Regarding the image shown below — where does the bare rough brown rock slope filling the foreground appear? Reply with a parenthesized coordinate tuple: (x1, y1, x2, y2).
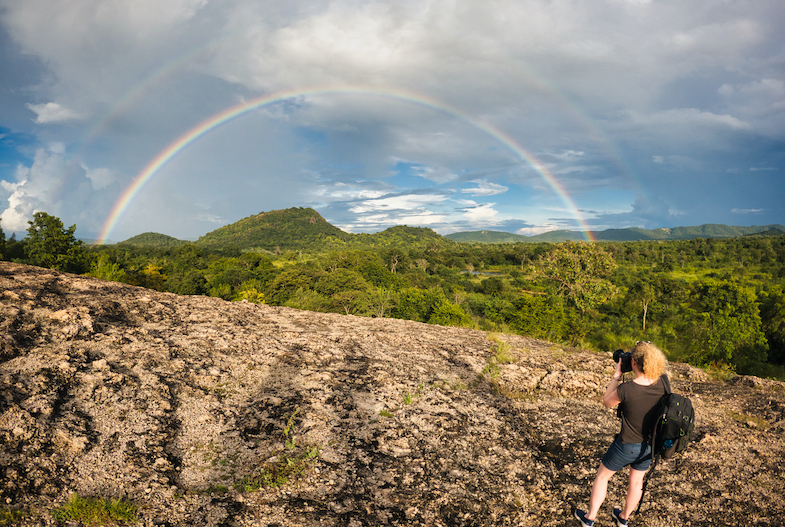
(0, 262, 785, 527)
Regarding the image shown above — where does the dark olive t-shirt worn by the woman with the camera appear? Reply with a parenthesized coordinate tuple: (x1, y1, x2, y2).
(616, 377, 666, 443)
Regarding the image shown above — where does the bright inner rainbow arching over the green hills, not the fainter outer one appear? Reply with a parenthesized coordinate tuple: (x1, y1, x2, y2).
(98, 86, 595, 244)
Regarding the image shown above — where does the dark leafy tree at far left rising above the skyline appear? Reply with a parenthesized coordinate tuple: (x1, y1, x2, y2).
(26, 212, 85, 272)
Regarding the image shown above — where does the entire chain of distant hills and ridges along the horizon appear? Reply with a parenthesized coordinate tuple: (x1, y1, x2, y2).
(116, 207, 785, 252)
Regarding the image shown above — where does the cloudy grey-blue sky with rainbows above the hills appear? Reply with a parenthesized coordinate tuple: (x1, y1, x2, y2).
(0, 0, 785, 243)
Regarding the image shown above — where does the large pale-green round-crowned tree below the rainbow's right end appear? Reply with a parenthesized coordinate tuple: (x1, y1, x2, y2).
(541, 242, 616, 314)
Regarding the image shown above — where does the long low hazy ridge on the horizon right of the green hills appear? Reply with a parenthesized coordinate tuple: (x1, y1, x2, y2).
(445, 223, 785, 243)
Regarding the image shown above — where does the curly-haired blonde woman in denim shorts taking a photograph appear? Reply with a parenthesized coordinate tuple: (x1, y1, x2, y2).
(575, 341, 668, 527)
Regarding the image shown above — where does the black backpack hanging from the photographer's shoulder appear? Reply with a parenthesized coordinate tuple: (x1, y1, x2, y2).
(636, 375, 695, 514)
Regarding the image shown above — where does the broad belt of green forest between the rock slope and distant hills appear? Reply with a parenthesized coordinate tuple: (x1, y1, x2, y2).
(0, 213, 785, 378)
